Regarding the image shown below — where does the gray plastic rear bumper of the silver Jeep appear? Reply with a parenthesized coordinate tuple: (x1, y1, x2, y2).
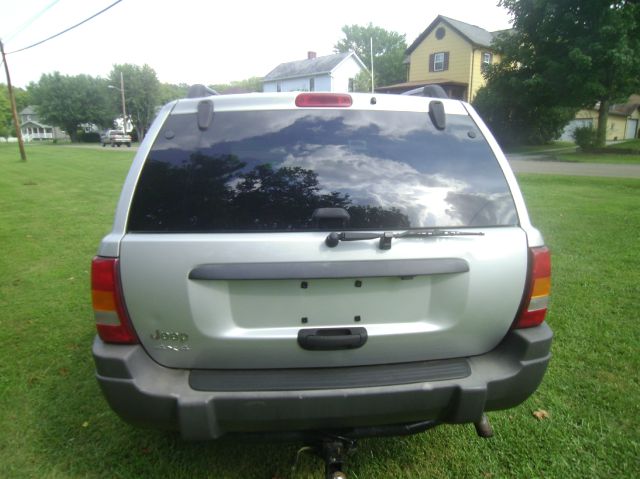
(93, 323, 553, 439)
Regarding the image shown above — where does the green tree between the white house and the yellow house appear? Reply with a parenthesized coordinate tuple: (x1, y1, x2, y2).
(333, 23, 407, 85)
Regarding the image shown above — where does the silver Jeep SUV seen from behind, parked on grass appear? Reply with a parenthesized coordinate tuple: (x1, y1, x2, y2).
(92, 93, 552, 456)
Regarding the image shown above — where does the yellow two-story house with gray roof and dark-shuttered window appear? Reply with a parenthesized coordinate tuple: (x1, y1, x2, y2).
(376, 15, 504, 101)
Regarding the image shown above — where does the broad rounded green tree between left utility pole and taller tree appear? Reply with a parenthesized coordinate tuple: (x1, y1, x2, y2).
(28, 72, 113, 141)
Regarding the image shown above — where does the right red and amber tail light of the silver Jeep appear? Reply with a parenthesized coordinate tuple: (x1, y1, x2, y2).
(514, 246, 551, 328)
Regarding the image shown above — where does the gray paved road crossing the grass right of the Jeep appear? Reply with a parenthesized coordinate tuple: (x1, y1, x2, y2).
(507, 154, 640, 178)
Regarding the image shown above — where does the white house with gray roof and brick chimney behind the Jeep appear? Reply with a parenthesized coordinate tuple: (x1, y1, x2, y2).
(262, 52, 367, 92)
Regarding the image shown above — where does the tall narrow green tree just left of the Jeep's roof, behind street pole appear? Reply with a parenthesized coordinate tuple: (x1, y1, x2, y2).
(109, 63, 160, 141)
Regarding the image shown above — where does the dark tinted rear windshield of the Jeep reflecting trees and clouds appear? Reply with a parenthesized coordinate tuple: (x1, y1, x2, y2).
(128, 109, 517, 232)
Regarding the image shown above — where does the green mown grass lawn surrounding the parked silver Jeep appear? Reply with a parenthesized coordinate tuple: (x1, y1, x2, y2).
(0, 145, 640, 479)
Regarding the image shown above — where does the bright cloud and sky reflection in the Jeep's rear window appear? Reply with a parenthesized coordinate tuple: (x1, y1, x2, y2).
(144, 110, 517, 227)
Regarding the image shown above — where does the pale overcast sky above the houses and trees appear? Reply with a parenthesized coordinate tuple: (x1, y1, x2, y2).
(0, 0, 510, 87)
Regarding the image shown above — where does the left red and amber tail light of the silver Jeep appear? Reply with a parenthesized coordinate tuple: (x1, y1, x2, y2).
(91, 256, 138, 344)
